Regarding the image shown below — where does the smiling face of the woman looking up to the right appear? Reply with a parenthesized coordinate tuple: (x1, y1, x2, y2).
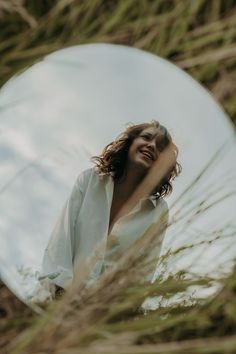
(128, 126, 168, 170)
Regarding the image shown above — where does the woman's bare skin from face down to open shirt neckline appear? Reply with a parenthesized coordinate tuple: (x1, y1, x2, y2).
(108, 127, 176, 234)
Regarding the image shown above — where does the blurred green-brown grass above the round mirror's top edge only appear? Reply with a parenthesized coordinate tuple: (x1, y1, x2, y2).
(0, 0, 236, 122)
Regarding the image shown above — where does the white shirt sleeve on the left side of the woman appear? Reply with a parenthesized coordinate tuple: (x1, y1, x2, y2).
(40, 174, 84, 288)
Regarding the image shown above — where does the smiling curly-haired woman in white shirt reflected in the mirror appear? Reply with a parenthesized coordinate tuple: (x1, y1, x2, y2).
(43, 121, 181, 296)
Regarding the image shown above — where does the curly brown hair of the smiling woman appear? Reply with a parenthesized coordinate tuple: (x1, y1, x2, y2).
(92, 120, 182, 199)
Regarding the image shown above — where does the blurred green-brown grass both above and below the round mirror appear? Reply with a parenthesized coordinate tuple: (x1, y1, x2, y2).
(0, 0, 236, 354)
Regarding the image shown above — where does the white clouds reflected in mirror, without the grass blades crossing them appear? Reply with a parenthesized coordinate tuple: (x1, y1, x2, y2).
(0, 44, 236, 300)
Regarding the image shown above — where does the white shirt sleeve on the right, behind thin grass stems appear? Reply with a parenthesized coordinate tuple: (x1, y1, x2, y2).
(146, 201, 169, 283)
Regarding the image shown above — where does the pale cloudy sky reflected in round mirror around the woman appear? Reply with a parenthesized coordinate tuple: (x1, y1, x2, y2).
(0, 44, 236, 308)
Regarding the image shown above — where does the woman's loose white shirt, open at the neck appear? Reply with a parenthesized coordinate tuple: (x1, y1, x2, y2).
(42, 168, 168, 288)
